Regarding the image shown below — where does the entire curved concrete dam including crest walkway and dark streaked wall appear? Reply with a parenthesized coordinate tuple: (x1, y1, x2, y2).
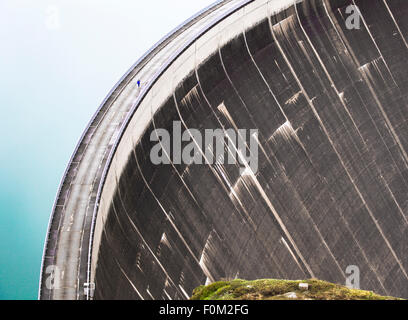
(39, 0, 408, 300)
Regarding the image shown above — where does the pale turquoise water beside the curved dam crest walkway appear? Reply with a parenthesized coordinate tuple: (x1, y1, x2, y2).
(0, 0, 213, 299)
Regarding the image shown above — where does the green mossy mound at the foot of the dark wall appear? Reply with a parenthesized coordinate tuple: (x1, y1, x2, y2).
(191, 279, 404, 300)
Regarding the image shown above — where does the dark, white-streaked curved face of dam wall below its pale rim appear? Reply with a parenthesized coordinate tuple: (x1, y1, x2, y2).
(40, 0, 408, 299)
